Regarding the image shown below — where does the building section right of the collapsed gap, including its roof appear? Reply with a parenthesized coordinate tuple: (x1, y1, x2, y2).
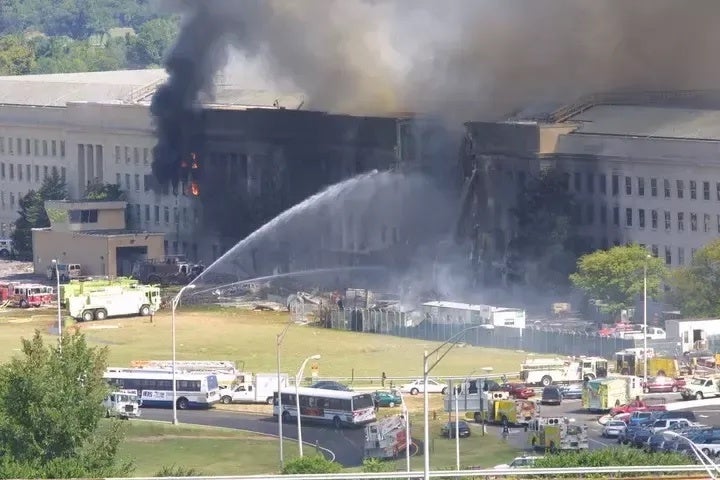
(459, 91, 720, 280)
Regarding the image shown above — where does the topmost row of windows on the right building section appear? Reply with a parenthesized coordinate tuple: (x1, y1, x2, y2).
(568, 172, 720, 201)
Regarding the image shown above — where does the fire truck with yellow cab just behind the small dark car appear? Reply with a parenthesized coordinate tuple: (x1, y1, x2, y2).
(444, 386, 538, 425)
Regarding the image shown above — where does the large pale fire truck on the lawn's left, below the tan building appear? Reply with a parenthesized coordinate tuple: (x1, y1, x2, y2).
(67, 286, 160, 322)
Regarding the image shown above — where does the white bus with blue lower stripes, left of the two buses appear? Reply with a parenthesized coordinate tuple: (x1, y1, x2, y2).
(103, 368, 220, 410)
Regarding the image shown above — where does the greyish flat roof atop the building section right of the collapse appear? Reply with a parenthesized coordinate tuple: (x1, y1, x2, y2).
(568, 105, 720, 140)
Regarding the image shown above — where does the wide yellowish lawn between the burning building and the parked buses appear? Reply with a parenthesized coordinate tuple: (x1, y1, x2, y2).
(0, 308, 525, 377)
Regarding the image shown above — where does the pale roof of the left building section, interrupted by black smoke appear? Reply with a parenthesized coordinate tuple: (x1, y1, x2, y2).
(0, 69, 305, 110)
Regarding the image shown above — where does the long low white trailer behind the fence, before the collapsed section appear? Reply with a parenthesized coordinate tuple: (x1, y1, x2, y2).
(422, 301, 525, 328)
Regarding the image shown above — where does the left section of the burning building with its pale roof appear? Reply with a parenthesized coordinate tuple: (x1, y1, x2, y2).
(0, 70, 416, 264)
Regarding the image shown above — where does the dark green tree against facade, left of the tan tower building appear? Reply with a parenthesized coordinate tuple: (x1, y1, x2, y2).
(12, 170, 67, 255)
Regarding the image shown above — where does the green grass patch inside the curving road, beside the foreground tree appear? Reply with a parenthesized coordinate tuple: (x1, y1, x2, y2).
(119, 420, 297, 477)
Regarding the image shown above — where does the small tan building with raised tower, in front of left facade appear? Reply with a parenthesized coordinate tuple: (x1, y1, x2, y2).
(32, 200, 165, 277)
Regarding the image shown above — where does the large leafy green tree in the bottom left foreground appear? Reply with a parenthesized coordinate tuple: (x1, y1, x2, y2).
(0, 331, 131, 478)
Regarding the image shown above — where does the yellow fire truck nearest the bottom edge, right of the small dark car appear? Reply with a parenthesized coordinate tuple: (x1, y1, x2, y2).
(528, 417, 590, 453)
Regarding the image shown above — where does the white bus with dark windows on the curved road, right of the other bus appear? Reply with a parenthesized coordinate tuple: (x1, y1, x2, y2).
(273, 387, 376, 428)
